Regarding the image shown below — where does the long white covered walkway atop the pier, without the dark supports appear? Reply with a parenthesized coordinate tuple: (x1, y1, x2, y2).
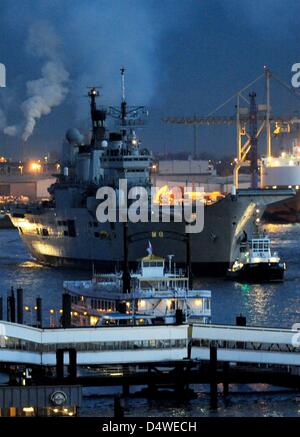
(0, 322, 300, 366)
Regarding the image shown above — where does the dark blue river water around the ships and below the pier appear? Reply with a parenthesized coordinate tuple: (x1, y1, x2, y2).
(0, 224, 300, 416)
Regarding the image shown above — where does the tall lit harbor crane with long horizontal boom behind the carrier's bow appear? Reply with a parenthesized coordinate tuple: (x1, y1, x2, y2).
(162, 66, 300, 188)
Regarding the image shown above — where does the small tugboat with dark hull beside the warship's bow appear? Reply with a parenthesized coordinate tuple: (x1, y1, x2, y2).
(227, 234, 286, 283)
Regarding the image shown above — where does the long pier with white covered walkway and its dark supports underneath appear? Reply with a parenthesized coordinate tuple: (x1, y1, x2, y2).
(0, 316, 300, 408)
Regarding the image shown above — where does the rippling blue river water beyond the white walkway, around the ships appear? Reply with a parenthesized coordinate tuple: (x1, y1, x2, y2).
(0, 224, 300, 328)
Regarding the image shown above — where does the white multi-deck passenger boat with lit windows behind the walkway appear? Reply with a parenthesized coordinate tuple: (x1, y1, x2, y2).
(63, 244, 211, 326)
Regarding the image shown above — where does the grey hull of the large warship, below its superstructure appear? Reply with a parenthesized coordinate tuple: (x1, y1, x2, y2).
(9, 190, 293, 276)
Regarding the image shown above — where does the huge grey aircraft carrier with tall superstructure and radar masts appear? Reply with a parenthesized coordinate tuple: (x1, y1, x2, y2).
(8, 70, 293, 275)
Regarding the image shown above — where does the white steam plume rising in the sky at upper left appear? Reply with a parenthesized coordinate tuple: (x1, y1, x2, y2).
(21, 22, 69, 141)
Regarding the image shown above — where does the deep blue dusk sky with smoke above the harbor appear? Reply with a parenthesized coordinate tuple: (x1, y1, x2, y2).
(0, 0, 300, 156)
